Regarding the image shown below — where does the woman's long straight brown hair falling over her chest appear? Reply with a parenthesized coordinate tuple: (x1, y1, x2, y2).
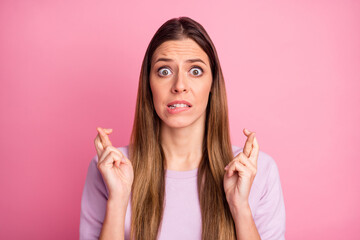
(129, 17, 236, 240)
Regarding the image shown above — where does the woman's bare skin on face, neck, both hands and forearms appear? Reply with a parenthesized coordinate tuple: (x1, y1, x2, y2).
(94, 39, 260, 239)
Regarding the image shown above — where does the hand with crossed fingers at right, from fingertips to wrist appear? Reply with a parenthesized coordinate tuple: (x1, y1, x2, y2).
(224, 129, 259, 209)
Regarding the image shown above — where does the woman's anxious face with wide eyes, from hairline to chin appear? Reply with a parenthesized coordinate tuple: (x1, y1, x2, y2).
(150, 38, 212, 128)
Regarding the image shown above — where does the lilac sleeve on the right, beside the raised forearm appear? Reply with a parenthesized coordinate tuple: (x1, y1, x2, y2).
(254, 157, 285, 240)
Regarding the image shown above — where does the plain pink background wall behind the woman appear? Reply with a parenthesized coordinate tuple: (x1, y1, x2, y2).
(0, 0, 360, 240)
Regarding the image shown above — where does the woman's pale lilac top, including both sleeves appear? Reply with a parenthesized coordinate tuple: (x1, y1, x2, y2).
(79, 146, 285, 240)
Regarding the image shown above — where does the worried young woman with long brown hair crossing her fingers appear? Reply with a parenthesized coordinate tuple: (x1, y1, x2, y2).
(80, 17, 285, 240)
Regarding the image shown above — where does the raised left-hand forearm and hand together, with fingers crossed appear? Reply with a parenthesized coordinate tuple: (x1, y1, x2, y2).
(94, 127, 134, 240)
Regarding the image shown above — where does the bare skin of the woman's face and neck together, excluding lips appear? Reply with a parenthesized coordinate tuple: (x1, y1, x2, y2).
(150, 39, 212, 171)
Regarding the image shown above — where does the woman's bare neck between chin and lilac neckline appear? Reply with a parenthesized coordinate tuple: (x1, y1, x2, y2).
(160, 116, 205, 171)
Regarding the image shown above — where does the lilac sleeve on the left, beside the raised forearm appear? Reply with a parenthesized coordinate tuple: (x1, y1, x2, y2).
(79, 155, 108, 240)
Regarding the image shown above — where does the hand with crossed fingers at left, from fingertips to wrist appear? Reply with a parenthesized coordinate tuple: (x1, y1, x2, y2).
(94, 127, 134, 199)
